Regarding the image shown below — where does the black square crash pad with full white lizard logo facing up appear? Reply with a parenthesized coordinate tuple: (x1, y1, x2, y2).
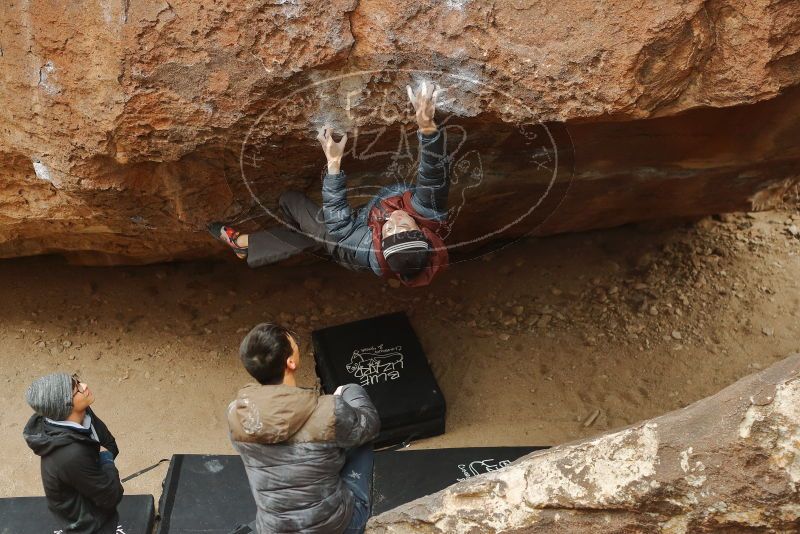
(311, 312, 445, 447)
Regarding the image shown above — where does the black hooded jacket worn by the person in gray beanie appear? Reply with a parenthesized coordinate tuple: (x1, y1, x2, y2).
(22, 409, 123, 534)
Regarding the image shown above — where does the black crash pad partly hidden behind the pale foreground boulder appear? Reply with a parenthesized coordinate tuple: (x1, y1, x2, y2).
(372, 447, 546, 515)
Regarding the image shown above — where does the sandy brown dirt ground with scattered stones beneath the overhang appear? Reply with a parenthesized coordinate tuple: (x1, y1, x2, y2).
(0, 200, 800, 497)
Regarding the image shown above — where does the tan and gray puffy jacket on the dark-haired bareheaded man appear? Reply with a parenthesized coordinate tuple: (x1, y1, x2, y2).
(228, 384, 380, 534)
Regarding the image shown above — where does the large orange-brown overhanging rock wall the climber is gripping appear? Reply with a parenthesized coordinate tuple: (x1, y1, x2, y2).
(0, 0, 800, 263)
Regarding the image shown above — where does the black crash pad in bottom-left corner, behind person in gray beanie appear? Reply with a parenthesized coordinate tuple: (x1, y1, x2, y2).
(0, 495, 155, 534)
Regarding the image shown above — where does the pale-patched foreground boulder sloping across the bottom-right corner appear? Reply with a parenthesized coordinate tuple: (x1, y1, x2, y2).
(367, 354, 800, 534)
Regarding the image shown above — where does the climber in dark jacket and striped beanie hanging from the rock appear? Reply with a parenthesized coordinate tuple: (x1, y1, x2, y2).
(209, 82, 450, 287)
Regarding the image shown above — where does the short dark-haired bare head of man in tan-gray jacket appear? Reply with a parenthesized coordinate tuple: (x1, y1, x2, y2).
(239, 323, 292, 385)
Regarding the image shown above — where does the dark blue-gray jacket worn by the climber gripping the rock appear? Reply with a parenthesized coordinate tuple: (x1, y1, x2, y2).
(322, 129, 450, 276)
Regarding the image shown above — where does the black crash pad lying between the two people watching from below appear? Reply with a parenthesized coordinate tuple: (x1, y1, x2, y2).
(157, 454, 256, 534)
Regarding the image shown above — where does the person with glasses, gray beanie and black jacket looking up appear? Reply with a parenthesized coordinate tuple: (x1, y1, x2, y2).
(22, 373, 123, 534)
